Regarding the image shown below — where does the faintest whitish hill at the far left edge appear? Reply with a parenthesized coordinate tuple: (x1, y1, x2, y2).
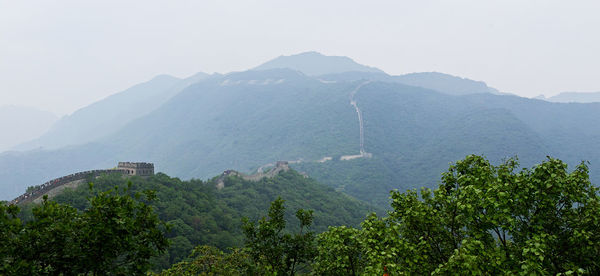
(0, 105, 58, 152)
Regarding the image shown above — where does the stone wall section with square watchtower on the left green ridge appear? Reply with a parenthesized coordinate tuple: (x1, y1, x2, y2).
(10, 162, 154, 204)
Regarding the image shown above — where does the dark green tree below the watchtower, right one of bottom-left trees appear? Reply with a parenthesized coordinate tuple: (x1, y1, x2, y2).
(81, 185, 169, 274)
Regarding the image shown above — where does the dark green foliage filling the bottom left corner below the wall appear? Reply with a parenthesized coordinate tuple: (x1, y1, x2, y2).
(0, 184, 168, 275)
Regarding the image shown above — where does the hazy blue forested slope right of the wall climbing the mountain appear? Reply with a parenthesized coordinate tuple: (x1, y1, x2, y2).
(296, 83, 600, 206)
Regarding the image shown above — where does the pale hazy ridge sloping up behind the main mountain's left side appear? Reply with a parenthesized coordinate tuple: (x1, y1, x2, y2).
(17, 73, 208, 150)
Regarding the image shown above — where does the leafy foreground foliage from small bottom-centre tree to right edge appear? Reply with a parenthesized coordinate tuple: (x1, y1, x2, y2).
(156, 155, 600, 275)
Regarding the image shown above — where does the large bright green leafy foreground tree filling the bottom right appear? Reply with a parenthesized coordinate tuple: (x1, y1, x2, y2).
(362, 155, 600, 275)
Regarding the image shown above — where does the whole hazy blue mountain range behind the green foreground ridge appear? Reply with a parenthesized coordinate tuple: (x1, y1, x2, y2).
(0, 52, 600, 206)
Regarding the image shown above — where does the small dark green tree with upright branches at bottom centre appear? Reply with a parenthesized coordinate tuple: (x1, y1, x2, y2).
(242, 198, 316, 275)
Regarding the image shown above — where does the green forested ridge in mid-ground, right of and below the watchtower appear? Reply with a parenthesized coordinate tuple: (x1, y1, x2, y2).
(34, 170, 379, 268)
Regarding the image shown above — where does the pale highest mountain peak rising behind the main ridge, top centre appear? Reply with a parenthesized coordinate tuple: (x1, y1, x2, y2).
(253, 51, 383, 76)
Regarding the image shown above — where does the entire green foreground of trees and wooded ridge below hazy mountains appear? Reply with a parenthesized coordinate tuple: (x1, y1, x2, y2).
(0, 155, 600, 275)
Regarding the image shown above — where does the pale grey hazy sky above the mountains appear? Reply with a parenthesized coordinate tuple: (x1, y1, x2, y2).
(0, 0, 600, 114)
